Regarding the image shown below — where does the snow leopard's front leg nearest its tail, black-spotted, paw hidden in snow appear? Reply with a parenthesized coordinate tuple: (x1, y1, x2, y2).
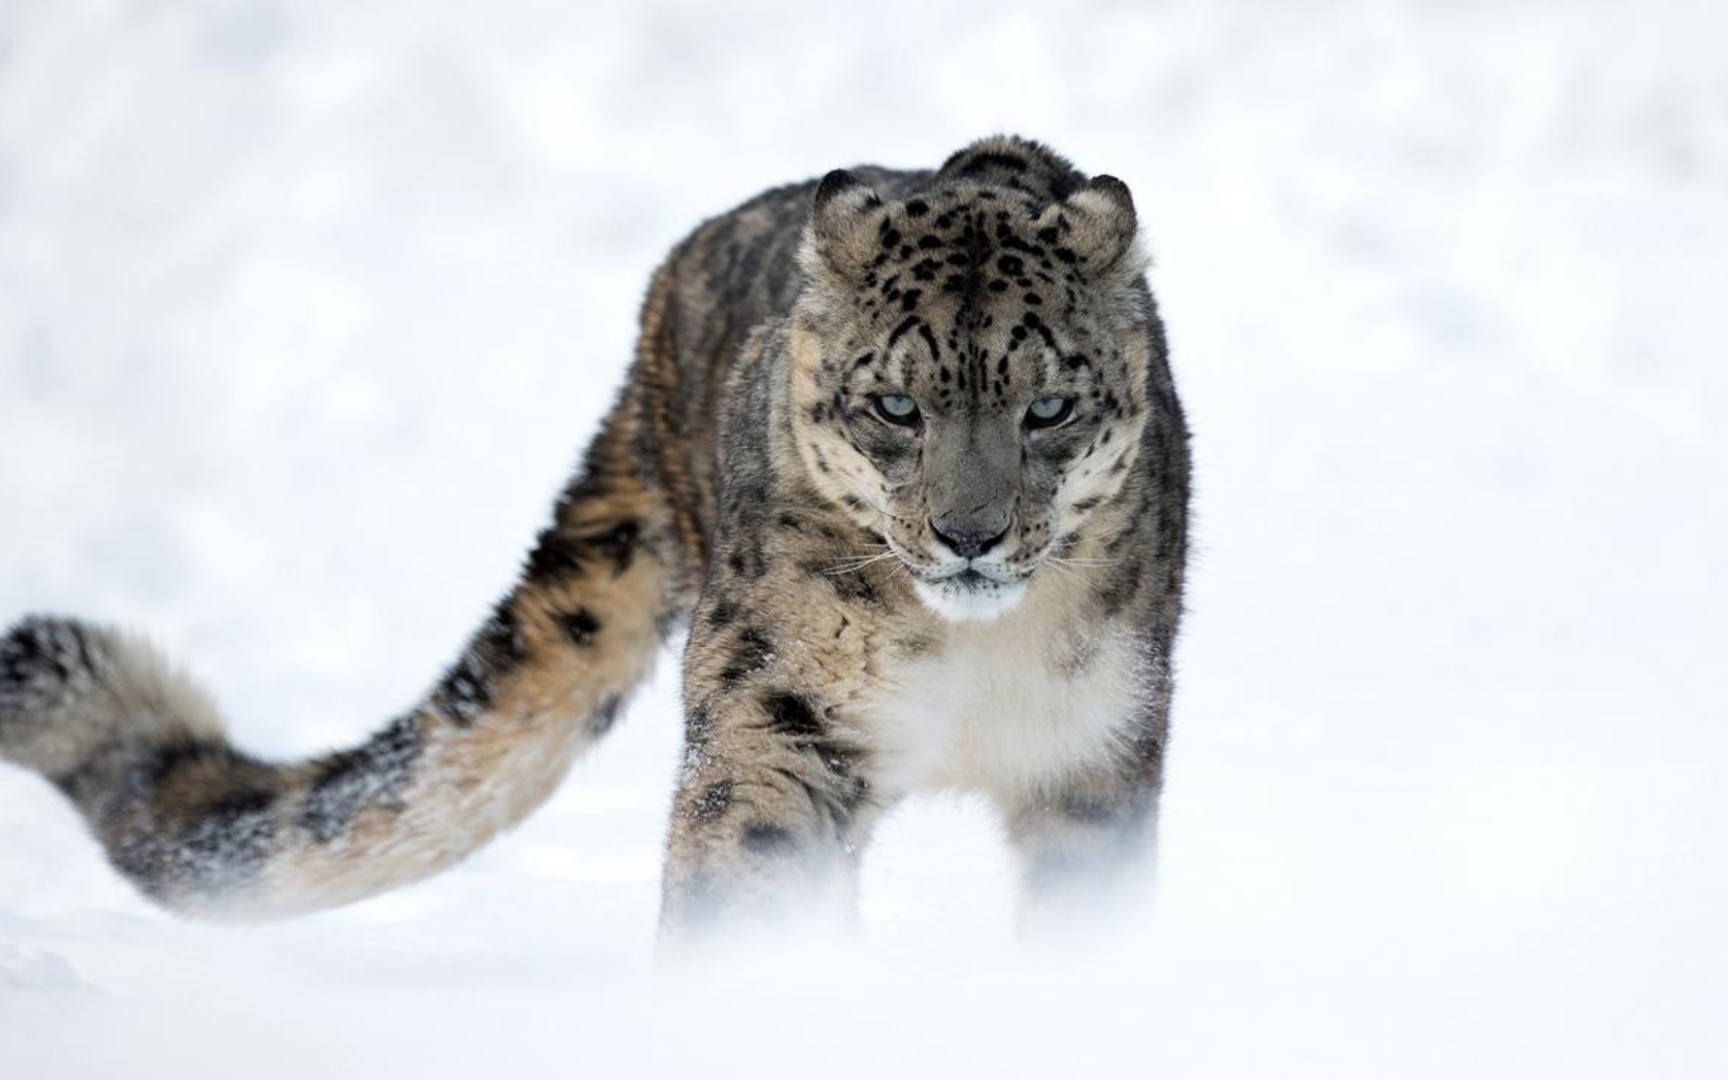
(660, 605, 874, 942)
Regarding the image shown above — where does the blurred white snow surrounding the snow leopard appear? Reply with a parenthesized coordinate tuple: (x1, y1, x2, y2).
(0, 0, 1728, 1080)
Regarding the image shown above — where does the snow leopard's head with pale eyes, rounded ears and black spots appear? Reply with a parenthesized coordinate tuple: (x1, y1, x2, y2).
(791, 173, 1149, 620)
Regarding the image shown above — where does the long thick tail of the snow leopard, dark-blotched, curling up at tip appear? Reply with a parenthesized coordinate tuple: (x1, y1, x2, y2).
(0, 403, 689, 919)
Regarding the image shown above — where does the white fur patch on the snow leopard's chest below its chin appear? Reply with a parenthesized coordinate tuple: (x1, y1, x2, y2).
(861, 605, 1147, 795)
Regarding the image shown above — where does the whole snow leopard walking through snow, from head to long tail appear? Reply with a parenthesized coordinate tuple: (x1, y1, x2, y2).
(0, 137, 1191, 940)
